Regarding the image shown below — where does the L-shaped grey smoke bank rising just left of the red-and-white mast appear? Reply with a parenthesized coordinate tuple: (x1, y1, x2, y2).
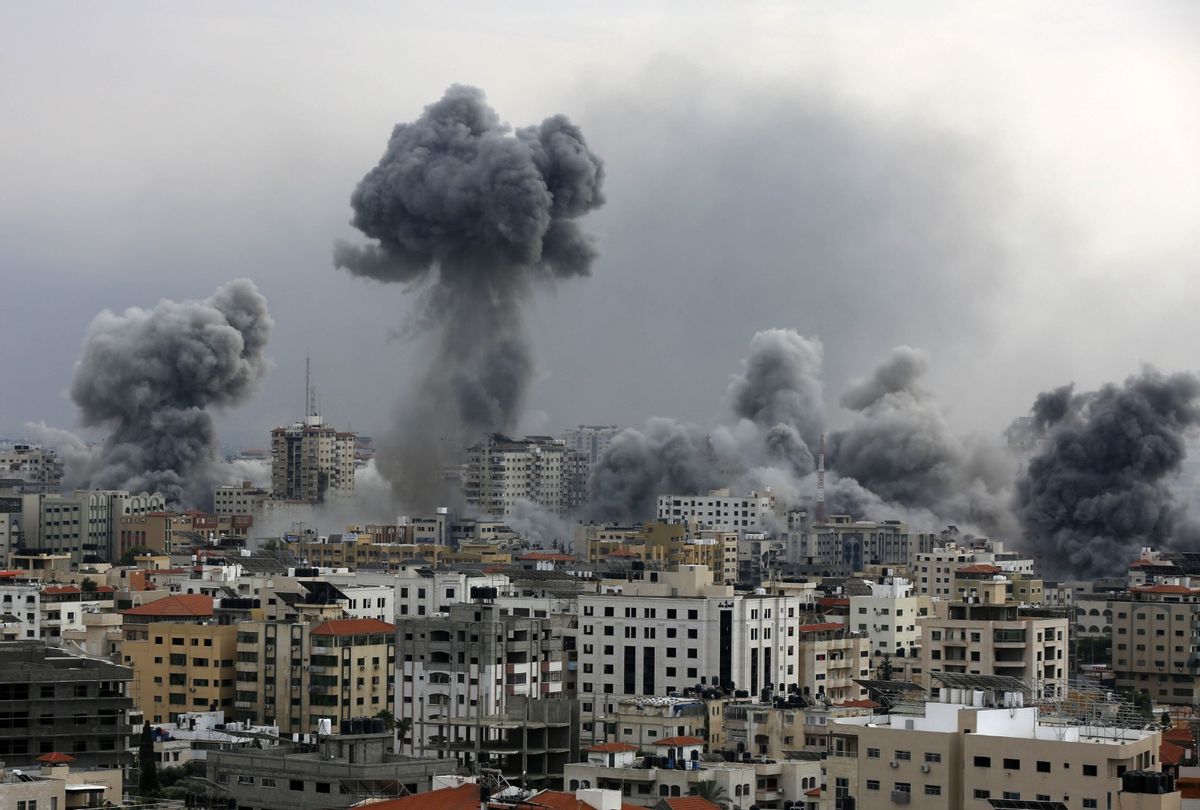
(589, 329, 824, 521)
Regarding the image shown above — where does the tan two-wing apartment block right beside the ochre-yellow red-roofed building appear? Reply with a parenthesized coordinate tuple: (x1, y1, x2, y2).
(234, 618, 396, 733)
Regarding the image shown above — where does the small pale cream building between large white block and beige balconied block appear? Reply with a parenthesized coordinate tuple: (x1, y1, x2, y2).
(848, 577, 932, 680)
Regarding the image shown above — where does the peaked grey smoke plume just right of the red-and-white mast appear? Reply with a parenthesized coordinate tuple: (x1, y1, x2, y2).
(828, 346, 1014, 536)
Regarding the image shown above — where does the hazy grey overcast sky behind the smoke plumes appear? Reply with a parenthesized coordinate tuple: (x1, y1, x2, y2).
(0, 0, 1200, 448)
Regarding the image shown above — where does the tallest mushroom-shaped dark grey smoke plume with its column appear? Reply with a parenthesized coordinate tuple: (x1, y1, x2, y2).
(334, 85, 604, 505)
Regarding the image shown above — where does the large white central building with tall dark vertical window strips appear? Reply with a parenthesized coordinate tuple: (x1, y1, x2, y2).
(578, 565, 815, 715)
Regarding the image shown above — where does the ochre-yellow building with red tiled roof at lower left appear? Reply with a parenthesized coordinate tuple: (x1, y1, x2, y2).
(120, 594, 236, 722)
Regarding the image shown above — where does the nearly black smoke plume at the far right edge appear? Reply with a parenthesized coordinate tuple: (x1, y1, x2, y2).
(1016, 370, 1200, 578)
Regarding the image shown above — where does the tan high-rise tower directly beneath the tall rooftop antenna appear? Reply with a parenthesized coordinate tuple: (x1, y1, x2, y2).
(271, 416, 355, 504)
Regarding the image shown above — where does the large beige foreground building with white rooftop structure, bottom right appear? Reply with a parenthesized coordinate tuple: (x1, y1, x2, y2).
(821, 676, 1180, 810)
